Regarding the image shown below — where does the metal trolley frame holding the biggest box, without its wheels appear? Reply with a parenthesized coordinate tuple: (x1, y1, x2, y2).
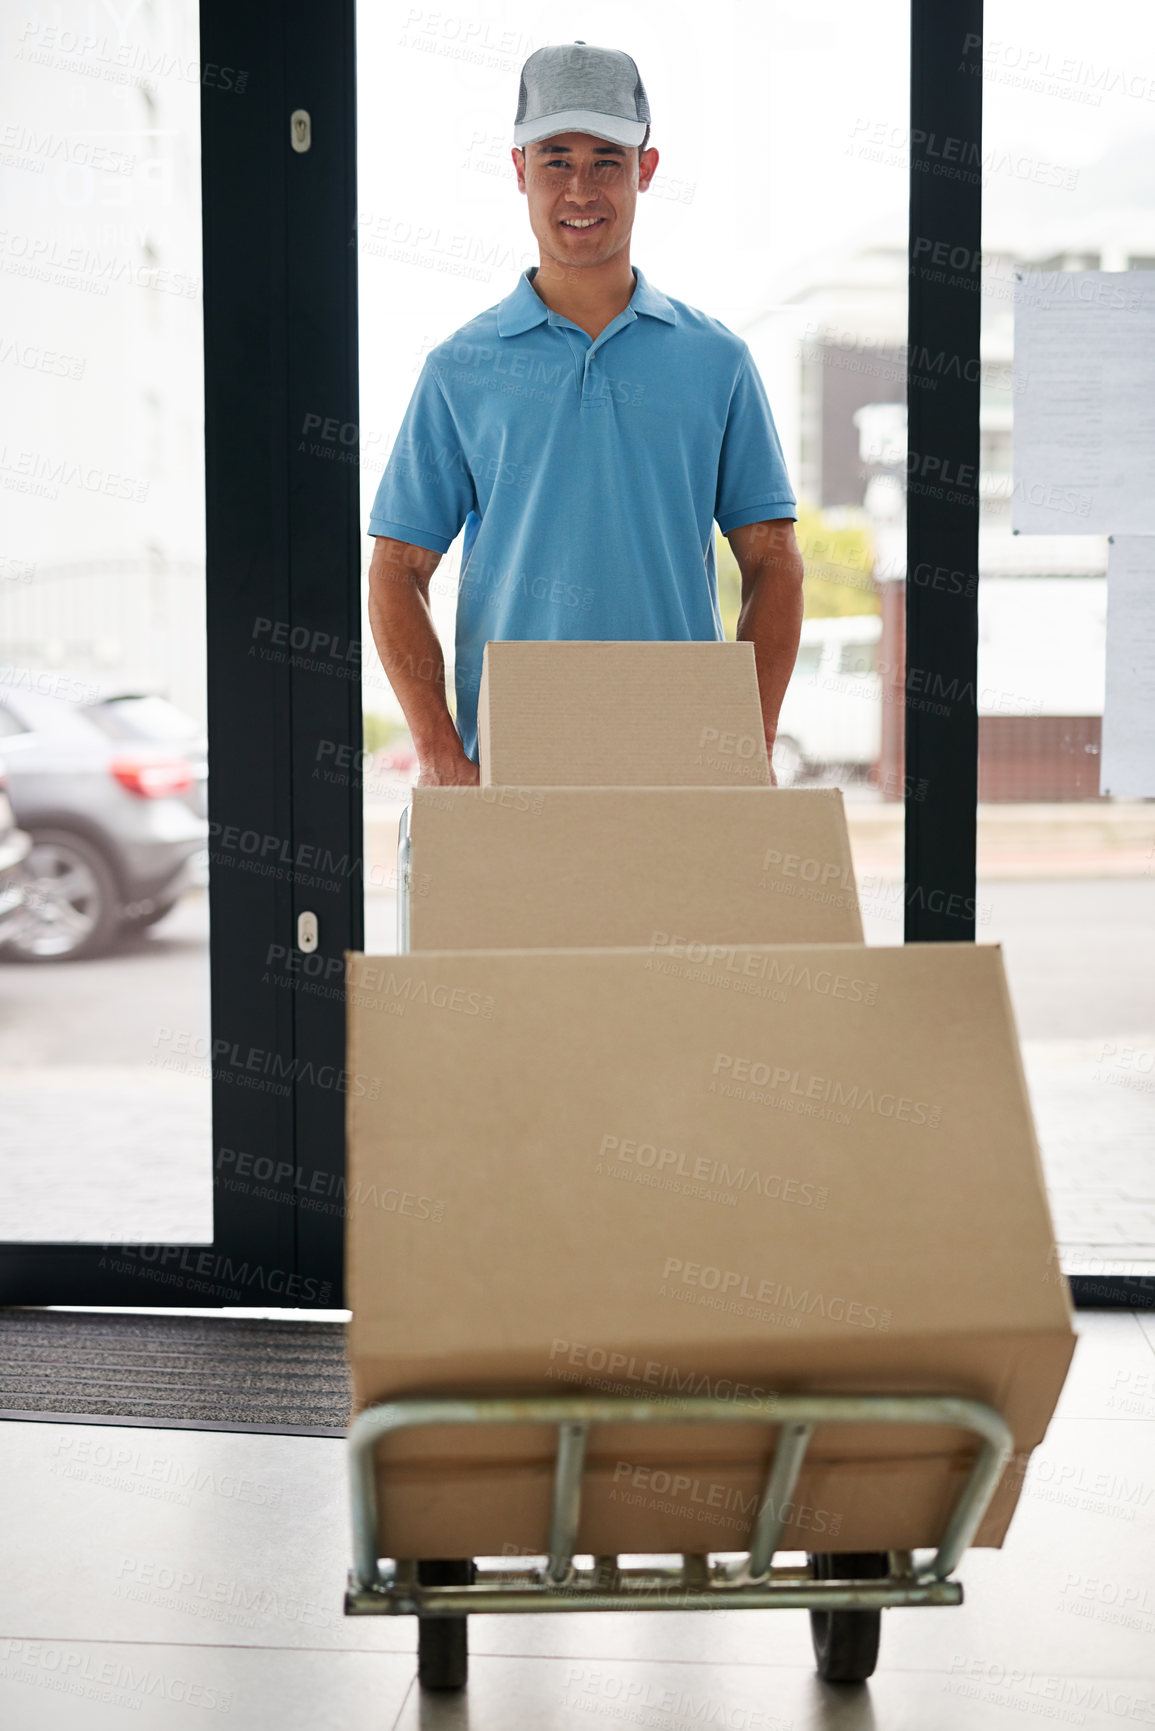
(345, 1393, 1011, 1617)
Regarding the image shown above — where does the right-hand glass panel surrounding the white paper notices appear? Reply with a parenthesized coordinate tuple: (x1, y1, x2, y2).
(971, 0, 1155, 1303)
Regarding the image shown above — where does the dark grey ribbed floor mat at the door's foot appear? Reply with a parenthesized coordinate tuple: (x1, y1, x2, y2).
(0, 1309, 350, 1437)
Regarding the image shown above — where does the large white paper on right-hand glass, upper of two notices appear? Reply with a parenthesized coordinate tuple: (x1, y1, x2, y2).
(1011, 270, 1155, 535)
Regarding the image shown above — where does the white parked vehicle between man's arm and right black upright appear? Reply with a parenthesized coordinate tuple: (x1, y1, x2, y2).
(774, 613, 881, 788)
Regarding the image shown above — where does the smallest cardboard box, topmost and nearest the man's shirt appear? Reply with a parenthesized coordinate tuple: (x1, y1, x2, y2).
(478, 642, 771, 788)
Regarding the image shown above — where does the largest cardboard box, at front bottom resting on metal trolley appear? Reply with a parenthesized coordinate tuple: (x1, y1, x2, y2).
(346, 943, 1074, 1556)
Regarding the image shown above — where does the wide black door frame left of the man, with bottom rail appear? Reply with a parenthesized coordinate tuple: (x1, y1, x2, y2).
(0, 0, 361, 1309)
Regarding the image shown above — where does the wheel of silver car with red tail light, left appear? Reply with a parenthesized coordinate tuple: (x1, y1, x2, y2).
(3, 829, 119, 962)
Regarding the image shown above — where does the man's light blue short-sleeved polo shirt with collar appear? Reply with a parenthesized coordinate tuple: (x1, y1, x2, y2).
(369, 265, 797, 760)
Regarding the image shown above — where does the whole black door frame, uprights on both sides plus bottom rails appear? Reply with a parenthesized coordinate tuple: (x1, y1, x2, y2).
(0, 0, 1135, 1309)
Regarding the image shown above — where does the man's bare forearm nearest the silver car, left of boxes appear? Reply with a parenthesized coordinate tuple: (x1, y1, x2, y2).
(369, 537, 464, 765)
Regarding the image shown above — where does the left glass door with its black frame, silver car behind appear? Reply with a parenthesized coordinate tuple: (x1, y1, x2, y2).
(0, 0, 362, 1309)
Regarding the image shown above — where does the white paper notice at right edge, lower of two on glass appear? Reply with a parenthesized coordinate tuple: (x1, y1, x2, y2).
(1100, 535, 1155, 800)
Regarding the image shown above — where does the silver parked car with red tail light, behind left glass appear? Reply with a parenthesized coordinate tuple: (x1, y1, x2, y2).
(0, 673, 208, 961)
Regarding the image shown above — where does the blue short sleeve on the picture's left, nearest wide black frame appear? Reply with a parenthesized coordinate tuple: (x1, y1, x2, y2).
(369, 357, 476, 552)
